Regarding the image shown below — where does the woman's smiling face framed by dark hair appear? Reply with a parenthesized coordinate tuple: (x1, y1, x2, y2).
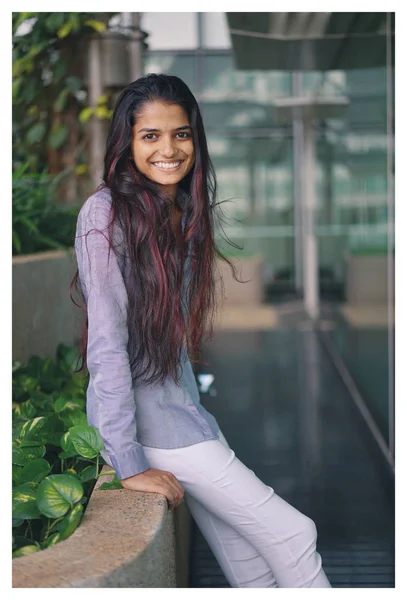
(131, 100, 195, 198)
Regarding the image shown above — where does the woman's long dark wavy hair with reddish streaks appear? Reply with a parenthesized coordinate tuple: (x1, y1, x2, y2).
(70, 74, 244, 383)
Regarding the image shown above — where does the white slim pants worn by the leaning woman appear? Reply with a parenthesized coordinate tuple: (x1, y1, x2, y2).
(144, 434, 331, 588)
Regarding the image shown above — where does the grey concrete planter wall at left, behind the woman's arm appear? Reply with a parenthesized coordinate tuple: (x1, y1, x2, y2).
(12, 248, 84, 361)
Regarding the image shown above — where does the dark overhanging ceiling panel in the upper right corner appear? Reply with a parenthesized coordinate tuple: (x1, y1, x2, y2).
(227, 12, 395, 71)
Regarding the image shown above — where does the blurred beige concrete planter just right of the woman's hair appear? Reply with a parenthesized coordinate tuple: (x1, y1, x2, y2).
(217, 255, 264, 309)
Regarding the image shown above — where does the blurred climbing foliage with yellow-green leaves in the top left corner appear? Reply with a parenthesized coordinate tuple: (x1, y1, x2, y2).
(12, 12, 117, 173)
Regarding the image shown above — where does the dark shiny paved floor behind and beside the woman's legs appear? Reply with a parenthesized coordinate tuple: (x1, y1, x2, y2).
(191, 323, 394, 588)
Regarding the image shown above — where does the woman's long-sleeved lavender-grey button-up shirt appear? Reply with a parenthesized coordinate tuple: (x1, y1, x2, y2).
(75, 188, 219, 479)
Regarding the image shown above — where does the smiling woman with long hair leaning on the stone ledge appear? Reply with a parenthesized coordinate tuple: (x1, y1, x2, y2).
(75, 74, 330, 587)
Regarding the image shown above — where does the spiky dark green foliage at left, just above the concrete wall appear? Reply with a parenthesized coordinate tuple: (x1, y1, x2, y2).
(12, 163, 80, 255)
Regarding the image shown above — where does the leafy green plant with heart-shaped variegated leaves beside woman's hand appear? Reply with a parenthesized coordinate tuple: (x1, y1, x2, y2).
(12, 345, 122, 557)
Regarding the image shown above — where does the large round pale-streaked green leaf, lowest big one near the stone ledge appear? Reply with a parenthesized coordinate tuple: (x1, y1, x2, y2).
(37, 475, 83, 518)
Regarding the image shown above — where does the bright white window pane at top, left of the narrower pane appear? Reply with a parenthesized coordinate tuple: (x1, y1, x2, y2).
(141, 12, 198, 50)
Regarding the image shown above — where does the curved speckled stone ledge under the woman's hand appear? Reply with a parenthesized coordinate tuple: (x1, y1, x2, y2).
(12, 465, 190, 588)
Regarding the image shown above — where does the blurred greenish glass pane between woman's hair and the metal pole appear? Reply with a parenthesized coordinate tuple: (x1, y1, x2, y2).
(208, 134, 294, 285)
